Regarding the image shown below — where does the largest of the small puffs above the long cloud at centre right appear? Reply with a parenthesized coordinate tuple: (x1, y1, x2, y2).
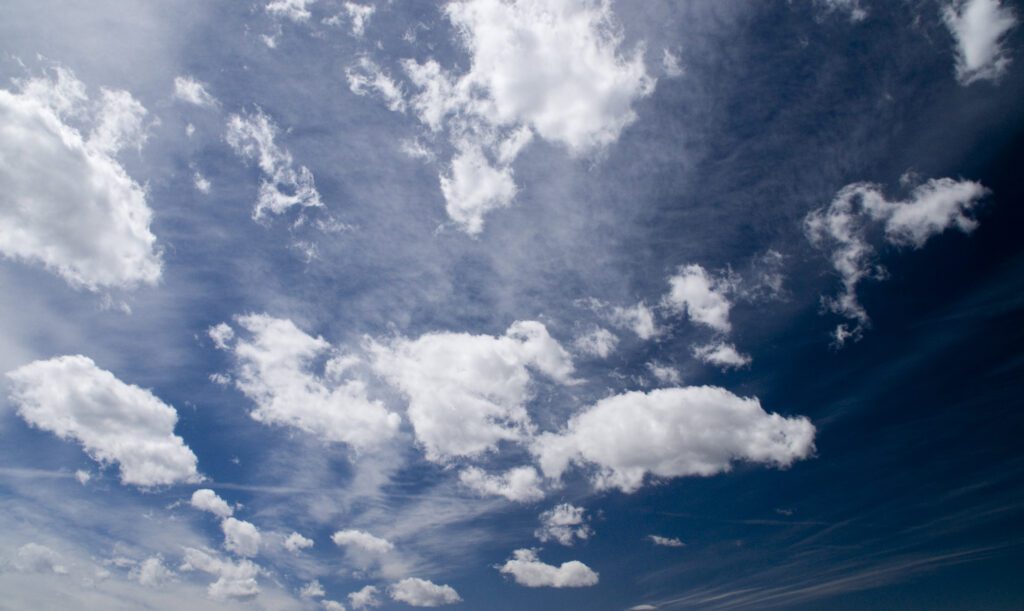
(663, 265, 732, 333)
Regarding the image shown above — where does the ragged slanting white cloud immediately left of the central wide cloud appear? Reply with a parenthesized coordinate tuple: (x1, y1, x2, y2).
(220, 314, 400, 449)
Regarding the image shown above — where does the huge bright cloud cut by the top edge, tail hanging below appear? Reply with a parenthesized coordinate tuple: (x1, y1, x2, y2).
(393, 0, 654, 234)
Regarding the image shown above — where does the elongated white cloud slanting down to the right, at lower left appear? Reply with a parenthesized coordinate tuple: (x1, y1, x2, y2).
(7, 355, 200, 487)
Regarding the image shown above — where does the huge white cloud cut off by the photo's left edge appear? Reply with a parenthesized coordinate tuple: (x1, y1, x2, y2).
(0, 68, 163, 291)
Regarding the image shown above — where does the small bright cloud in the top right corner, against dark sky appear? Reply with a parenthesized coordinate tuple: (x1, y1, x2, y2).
(942, 0, 1017, 86)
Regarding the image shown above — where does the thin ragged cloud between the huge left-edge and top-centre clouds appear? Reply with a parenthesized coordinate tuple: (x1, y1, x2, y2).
(225, 108, 324, 220)
